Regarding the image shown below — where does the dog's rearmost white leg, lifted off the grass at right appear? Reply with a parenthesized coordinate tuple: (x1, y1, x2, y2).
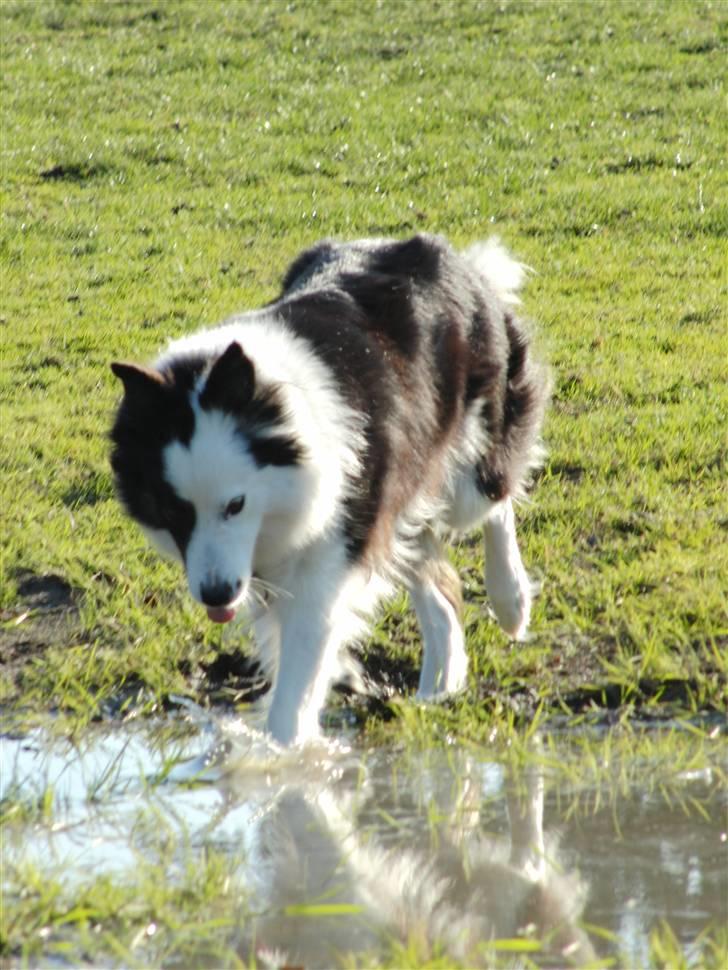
(483, 498, 532, 640)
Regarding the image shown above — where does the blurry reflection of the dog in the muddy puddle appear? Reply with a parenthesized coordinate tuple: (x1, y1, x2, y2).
(233, 765, 595, 968)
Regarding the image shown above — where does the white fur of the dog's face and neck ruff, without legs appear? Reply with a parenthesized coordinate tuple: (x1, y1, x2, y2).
(147, 315, 360, 605)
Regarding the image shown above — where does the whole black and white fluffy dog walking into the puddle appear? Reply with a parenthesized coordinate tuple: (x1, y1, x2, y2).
(111, 234, 548, 746)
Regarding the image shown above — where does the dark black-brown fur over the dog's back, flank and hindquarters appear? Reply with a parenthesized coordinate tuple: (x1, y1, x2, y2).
(270, 235, 546, 558)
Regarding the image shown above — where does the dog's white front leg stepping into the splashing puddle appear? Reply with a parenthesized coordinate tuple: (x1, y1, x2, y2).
(267, 548, 361, 745)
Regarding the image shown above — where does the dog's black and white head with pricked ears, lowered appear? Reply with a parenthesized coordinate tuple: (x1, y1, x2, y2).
(111, 343, 302, 622)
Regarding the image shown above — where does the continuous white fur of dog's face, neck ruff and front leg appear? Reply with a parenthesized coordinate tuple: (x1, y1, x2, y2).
(151, 317, 389, 744)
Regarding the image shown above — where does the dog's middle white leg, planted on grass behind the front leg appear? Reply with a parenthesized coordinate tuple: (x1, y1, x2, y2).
(408, 531, 468, 700)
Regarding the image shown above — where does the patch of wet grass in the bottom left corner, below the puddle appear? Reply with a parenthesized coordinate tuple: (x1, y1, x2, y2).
(3, 840, 248, 967)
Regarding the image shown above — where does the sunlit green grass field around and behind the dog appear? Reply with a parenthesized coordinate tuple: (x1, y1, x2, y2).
(0, 0, 728, 965)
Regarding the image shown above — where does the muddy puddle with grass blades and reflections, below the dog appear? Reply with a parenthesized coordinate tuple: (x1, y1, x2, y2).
(0, 708, 728, 967)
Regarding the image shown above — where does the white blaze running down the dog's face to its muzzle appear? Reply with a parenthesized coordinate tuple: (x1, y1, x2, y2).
(163, 408, 266, 605)
